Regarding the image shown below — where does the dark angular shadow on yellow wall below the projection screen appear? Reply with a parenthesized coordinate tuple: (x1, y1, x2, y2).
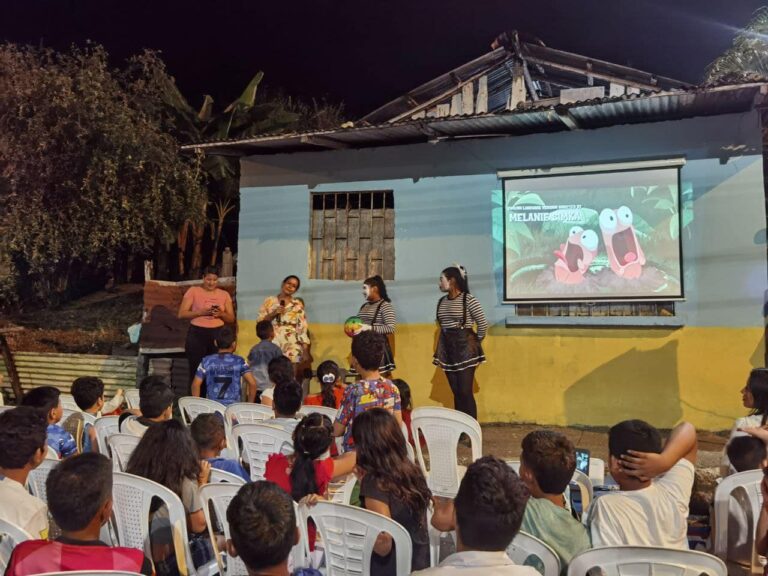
(565, 342, 682, 428)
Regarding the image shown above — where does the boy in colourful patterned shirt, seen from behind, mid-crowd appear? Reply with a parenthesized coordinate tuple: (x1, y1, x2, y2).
(333, 331, 403, 452)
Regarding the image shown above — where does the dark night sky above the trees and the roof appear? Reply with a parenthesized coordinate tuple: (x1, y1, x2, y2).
(0, 0, 768, 118)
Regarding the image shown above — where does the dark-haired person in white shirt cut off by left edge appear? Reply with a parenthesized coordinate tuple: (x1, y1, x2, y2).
(0, 406, 48, 540)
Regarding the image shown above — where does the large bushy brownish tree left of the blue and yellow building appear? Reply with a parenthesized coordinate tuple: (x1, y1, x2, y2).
(0, 44, 205, 304)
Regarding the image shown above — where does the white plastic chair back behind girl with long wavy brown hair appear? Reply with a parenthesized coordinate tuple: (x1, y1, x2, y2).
(299, 501, 413, 576)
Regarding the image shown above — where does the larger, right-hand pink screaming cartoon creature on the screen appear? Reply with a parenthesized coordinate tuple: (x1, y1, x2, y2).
(600, 206, 645, 280)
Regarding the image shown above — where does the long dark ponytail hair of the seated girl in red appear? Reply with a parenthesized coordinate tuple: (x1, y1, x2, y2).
(291, 412, 333, 502)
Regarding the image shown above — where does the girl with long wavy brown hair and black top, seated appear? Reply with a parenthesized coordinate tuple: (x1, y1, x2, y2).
(352, 408, 432, 576)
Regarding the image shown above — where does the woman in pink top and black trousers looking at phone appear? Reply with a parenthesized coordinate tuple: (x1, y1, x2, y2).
(179, 266, 235, 392)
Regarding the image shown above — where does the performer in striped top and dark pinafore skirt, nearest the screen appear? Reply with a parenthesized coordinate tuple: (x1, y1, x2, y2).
(432, 264, 488, 419)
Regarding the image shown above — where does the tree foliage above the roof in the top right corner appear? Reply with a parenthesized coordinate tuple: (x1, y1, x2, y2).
(705, 6, 768, 82)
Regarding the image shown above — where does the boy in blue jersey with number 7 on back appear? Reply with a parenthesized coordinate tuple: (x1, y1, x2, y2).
(192, 326, 256, 406)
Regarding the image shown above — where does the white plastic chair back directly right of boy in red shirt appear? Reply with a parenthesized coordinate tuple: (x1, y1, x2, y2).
(112, 472, 195, 576)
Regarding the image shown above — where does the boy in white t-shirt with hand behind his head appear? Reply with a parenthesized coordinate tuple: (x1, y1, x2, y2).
(587, 420, 697, 550)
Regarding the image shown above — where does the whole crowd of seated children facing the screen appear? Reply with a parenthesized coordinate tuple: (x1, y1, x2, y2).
(0, 327, 768, 576)
